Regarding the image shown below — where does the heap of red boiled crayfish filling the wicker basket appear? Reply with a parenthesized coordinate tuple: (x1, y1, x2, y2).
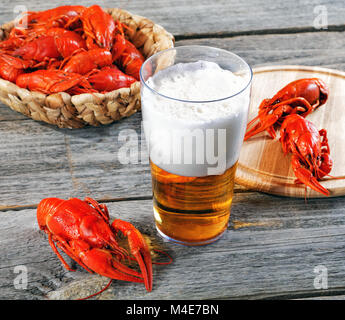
(0, 5, 144, 95)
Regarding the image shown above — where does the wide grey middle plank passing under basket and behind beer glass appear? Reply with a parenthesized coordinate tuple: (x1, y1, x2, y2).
(0, 32, 345, 205)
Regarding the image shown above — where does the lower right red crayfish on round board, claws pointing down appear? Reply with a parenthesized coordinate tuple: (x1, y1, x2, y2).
(280, 114, 333, 196)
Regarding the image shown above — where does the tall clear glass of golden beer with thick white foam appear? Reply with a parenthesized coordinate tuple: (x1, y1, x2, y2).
(140, 46, 252, 245)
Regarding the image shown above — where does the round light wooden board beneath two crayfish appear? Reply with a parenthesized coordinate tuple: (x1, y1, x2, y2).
(236, 66, 345, 198)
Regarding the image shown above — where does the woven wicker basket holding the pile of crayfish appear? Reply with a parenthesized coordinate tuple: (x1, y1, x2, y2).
(0, 9, 174, 129)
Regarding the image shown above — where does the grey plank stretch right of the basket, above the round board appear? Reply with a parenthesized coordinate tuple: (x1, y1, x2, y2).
(176, 32, 345, 70)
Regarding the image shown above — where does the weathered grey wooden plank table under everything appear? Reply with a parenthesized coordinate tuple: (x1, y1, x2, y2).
(0, 0, 345, 299)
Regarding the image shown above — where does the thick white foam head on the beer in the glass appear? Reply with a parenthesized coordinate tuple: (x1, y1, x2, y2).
(141, 61, 250, 176)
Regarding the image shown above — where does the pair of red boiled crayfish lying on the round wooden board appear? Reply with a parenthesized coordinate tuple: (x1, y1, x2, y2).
(244, 78, 336, 196)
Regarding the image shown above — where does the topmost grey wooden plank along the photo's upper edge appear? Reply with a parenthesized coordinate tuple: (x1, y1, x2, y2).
(0, 0, 345, 37)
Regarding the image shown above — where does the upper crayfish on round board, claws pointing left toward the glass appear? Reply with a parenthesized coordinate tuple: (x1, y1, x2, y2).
(244, 78, 328, 140)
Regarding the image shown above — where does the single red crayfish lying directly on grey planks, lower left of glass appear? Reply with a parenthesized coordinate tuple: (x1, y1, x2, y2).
(37, 198, 152, 291)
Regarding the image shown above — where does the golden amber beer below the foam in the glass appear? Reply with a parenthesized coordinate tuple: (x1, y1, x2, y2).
(150, 161, 237, 245)
